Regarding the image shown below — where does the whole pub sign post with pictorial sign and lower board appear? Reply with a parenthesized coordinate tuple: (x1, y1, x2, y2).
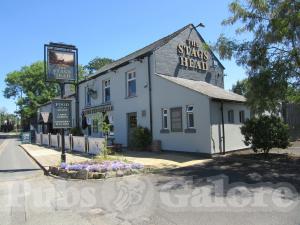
(44, 42, 78, 162)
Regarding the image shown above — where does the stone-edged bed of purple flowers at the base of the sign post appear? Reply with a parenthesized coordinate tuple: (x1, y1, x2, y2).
(49, 161, 144, 179)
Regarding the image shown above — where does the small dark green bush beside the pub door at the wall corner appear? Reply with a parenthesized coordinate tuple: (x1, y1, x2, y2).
(131, 126, 152, 148)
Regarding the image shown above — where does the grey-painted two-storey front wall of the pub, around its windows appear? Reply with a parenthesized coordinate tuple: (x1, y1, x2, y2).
(79, 57, 150, 146)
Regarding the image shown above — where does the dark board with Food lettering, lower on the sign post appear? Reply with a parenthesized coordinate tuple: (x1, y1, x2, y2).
(52, 99, 72, 129)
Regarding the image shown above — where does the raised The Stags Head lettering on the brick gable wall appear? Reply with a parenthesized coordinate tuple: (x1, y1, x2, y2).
(177, 40, 209, 70)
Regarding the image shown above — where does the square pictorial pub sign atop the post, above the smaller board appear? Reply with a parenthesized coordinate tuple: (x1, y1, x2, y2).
(44, 42, 78, 83)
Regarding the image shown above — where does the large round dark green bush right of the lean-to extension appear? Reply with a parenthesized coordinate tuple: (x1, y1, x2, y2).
(241, 116, 289, 154)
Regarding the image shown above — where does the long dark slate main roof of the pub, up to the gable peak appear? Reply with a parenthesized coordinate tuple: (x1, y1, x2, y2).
(79, 24, 223, 83)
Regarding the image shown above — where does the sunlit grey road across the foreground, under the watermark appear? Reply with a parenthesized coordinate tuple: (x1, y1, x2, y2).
(0, 134, 300, 225)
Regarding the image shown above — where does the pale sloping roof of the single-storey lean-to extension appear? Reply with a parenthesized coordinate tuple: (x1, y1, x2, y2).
(156, 74, 246, 102)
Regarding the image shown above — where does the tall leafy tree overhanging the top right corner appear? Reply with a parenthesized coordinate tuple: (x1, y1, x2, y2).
(215, 0, 300, 114)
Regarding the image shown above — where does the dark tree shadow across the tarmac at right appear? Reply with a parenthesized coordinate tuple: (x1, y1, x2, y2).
(157, 154, 300, 193)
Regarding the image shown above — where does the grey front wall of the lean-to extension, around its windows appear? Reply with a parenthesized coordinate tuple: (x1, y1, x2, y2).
(152, 75, 211, 154)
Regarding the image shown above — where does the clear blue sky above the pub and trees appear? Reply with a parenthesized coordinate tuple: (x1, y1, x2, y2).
(0, 0, 246, 112)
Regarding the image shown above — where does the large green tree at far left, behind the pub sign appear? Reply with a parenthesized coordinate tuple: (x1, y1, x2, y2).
(4, 61, 59, 126)
